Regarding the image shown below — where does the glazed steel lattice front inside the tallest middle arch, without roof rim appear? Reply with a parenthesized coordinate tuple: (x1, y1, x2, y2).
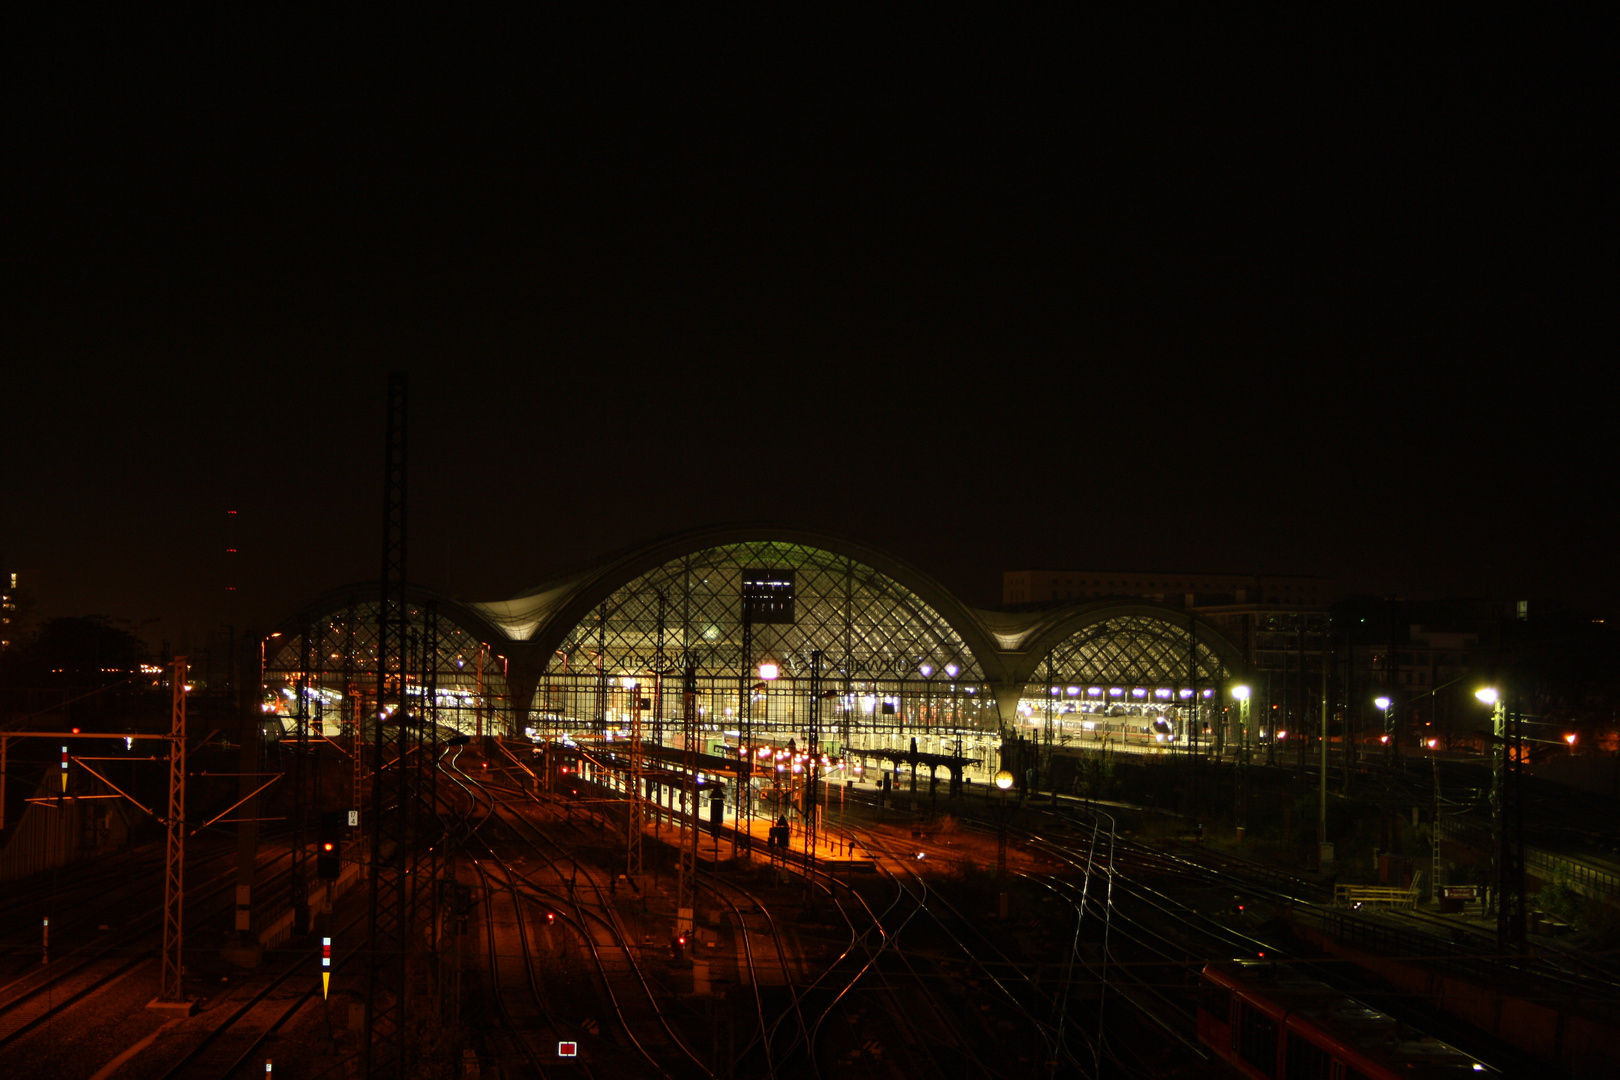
(531, 541, 993, 743)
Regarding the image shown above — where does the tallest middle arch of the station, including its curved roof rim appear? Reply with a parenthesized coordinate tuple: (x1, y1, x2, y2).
(481, 526, 1000, 761)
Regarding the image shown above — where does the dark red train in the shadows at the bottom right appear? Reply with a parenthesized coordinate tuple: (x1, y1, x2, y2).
(1199, 960, 1502, 1080)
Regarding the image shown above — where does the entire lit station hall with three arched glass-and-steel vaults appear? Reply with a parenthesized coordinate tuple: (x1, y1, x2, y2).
(264, 528, 1237, 779)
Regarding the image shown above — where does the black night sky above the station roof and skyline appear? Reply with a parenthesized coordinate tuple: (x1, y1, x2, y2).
(0, 10, 1620, 643)
